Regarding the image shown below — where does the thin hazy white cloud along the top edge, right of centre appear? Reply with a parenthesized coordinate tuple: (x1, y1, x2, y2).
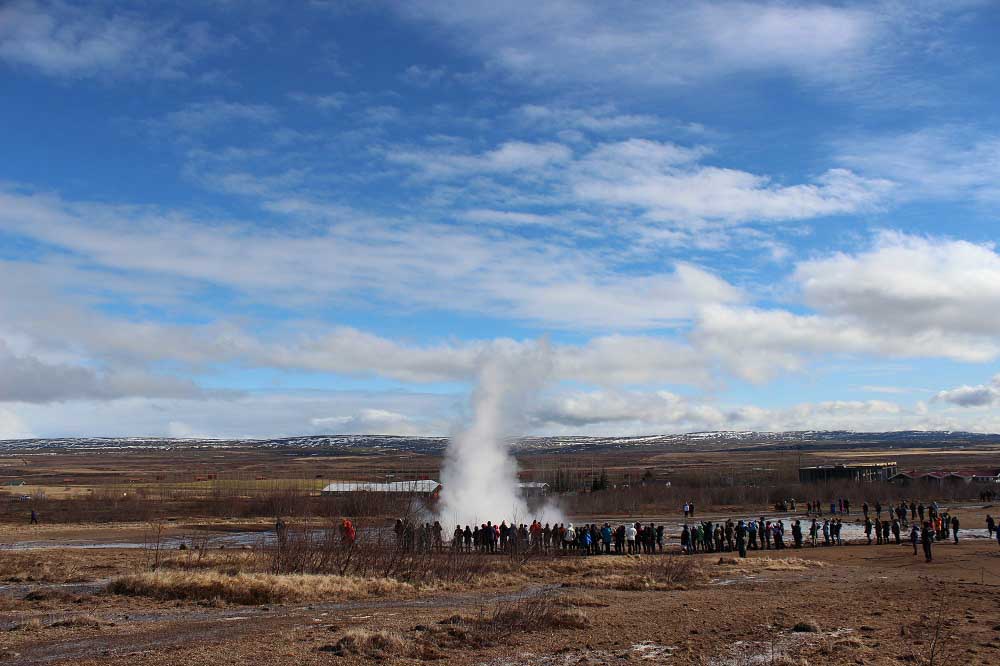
(398, 1, 890, 86)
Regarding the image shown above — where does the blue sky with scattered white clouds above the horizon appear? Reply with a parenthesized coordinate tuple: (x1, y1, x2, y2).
(0, 0, 1000, 438)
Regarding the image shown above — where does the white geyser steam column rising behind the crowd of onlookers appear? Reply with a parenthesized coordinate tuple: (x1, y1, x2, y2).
(438, 342, 561, 526)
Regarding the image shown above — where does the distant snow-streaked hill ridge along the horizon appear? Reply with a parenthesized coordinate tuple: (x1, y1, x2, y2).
(0, 430, 1000, 454)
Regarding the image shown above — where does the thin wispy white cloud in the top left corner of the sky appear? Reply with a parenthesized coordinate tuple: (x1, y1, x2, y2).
(0, 0, 217, 79)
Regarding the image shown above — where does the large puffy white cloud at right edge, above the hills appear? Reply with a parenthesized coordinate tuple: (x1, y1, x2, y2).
(693, 233, 1000, 381)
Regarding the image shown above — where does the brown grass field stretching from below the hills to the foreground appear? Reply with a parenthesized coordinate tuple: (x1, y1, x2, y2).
(0, 449, 1000, 665)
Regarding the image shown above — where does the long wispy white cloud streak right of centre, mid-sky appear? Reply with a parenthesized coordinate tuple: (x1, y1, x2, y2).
(387, 139, 892, 228)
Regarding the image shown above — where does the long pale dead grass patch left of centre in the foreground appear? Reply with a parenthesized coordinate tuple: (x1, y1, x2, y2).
(107, 571, 415, 605)
